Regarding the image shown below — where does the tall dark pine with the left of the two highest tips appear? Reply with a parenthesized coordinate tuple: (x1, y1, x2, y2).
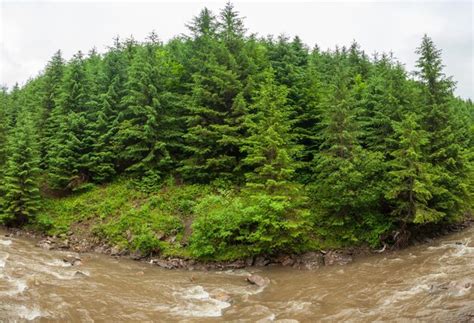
(179, 10, 241, 182)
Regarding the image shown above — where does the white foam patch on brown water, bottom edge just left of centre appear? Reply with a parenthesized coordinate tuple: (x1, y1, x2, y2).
(169, 285, 231, 317)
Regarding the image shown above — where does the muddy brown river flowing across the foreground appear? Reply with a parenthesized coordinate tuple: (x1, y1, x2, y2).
(0, 228, 474, 322)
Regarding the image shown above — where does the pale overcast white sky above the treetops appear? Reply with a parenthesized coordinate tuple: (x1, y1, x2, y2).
(0, 0, 474, 99)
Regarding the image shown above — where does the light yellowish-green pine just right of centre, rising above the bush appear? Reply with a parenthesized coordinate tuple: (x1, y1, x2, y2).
(242, 71, 301, 194)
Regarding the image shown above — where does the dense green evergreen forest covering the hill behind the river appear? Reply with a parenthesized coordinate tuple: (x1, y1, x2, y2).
(0, 3, 474, 255)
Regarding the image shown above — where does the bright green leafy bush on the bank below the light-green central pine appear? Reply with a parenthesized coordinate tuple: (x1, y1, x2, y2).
(191, 193, 309, 260)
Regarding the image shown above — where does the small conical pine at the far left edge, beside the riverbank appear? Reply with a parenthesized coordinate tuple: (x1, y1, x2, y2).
(0, 113, 40, 225)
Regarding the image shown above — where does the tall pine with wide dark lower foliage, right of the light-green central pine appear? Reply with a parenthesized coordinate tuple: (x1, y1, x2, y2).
(311, 74, 387, 244)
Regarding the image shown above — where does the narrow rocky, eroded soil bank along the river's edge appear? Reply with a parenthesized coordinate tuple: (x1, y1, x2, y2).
(3, 220, 474, 270)
